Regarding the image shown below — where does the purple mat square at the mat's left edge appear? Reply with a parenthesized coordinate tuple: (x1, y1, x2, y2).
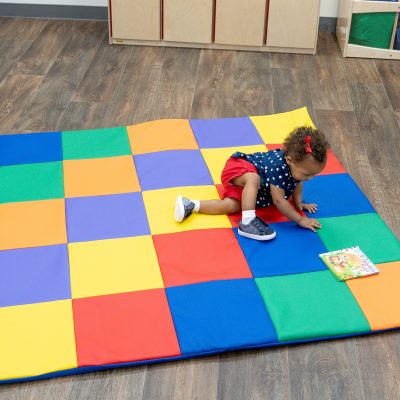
(0, 245, 71, 307)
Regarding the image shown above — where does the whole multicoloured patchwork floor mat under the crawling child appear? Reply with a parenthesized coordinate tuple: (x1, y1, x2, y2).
(0, 108, 400, 383)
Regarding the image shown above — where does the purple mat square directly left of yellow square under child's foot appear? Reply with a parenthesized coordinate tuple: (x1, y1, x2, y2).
(65, 192, 150, 242)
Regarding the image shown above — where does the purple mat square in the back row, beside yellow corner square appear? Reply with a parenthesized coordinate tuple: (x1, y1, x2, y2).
(190, 117, 264, 148)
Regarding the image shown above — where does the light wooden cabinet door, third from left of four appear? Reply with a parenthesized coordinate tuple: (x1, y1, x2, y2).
(215, 0, 266, 46)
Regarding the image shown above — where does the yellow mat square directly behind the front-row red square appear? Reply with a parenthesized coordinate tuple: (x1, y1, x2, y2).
(68, 236, 164, 298)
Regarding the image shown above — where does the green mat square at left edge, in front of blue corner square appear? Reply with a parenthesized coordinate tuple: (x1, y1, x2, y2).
(0, 161, 64, 204)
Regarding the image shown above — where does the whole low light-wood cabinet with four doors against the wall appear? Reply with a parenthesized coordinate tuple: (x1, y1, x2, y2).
(109, 0, 320, 54)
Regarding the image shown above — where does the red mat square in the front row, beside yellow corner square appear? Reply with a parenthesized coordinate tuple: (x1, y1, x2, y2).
(73, 289, 181, 367)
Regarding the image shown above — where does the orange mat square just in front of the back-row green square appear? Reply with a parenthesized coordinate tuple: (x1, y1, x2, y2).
(64, 156, 140, 197)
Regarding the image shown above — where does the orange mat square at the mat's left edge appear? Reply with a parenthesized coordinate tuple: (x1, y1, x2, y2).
(0, 199, 67, 250)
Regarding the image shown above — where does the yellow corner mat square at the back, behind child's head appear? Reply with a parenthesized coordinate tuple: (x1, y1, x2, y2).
(250, 107, 315, 144)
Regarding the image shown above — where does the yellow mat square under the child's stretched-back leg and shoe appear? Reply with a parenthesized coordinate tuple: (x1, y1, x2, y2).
(143, 186, 232, 235)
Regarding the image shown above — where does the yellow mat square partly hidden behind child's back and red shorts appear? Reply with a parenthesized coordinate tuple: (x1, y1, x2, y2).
(201, 144, 267, 185)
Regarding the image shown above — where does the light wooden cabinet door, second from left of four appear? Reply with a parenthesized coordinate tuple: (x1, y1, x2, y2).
(164, 0, 213, 43)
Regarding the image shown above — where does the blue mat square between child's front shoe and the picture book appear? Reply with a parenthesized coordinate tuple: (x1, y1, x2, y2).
(235, 222, 328, 278)
